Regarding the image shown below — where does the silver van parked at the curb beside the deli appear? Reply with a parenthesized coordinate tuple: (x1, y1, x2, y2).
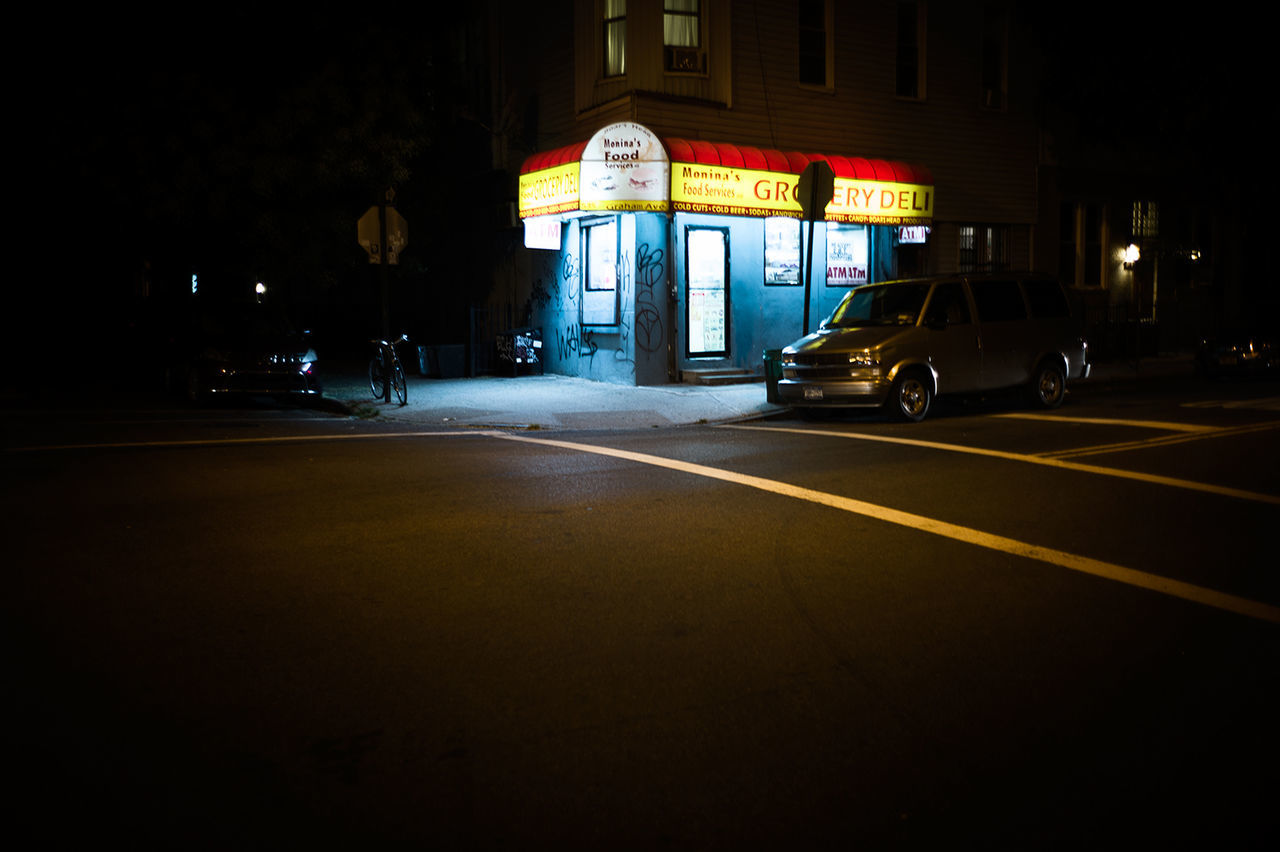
(778, 275, 1089, 421)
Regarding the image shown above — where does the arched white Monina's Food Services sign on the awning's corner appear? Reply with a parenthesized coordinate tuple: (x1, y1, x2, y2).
(581, 122, 671, 212)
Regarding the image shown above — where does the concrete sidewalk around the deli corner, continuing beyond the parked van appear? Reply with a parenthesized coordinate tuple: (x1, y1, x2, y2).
(320, 356, 1194, 430)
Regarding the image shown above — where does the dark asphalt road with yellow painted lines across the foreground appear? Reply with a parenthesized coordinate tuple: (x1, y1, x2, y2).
(3, 383, 1280, 849)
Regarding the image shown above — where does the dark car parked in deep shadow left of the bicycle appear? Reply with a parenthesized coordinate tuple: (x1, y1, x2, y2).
(165, 299, 323, 402)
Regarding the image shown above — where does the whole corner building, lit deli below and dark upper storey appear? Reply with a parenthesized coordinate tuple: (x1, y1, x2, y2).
(495, 0, 1057, 384)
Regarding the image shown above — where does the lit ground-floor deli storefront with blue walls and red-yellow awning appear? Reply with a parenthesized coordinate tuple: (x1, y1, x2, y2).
(520, 122, 934, 385)
